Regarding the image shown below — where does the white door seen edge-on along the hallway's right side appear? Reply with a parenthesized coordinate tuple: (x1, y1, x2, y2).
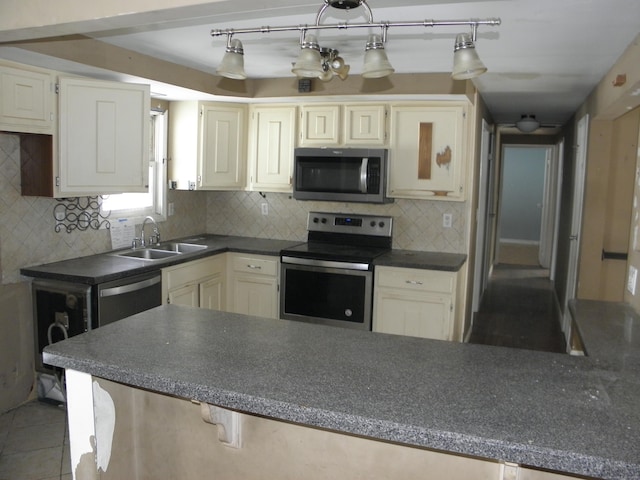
(562, 115, 589, 338)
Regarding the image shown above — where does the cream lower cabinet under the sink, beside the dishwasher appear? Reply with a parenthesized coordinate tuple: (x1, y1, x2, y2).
(162, 254, 226, 310)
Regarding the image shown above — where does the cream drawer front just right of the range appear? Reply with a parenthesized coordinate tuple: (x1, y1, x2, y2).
(376, 267, 457, 294)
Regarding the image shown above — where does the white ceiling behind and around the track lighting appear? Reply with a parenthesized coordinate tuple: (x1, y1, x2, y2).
(0, 0, 640, 124)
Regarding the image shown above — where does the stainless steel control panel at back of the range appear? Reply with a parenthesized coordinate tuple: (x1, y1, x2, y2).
(307, 212, 393, 237)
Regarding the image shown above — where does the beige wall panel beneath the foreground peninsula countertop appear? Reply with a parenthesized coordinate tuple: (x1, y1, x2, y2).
(94, 379, 578, 480)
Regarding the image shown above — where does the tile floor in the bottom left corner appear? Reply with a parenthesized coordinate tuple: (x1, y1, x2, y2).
(0, 400, 72, 480)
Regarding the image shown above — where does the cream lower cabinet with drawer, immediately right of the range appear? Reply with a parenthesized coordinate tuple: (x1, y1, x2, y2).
(373, 266, 458, 340)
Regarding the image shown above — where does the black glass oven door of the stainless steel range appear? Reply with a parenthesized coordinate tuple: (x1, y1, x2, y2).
(280, 259, 373, 330)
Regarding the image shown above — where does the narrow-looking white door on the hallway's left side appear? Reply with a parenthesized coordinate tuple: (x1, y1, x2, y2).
(472, 120, 493, 313)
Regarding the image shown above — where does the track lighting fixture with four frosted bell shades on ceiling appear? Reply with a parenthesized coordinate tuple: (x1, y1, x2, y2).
(211, 0, 501, 81)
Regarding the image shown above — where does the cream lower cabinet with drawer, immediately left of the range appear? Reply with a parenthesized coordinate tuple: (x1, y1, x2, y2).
(228, 253, 279, 318)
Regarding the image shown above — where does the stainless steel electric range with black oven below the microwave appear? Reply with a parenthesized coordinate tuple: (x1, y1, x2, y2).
(280, 212, 393, 330)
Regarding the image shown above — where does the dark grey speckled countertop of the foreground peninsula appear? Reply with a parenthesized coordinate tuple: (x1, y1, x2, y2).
(44, 305, 640, 479)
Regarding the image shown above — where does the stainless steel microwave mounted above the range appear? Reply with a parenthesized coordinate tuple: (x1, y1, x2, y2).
(293, 148, 392, 203)
